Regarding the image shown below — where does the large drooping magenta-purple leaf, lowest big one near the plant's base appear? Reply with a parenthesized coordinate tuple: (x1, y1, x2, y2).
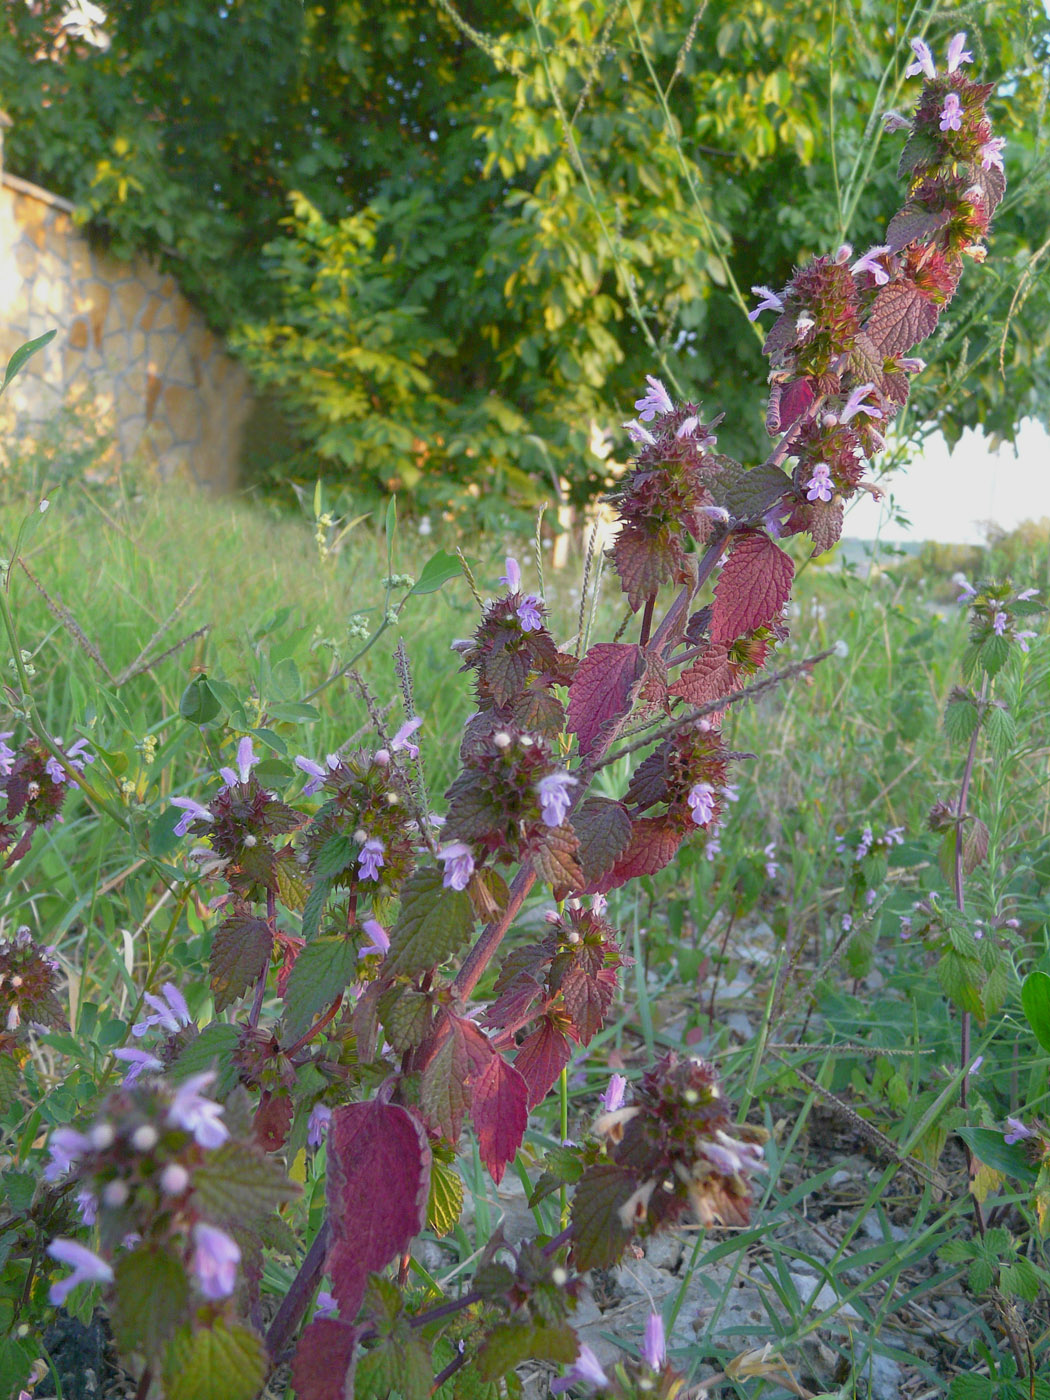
(326, 1099, 430, 1317)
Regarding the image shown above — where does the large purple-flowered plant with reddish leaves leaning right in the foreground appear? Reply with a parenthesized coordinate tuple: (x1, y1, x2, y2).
(0, 35, 1005, 1400)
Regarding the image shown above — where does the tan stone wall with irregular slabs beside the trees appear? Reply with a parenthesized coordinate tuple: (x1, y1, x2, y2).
(0, 133, 252, 491)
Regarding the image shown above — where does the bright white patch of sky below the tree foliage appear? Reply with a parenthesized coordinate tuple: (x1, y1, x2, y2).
(843, 419, 1050, 545)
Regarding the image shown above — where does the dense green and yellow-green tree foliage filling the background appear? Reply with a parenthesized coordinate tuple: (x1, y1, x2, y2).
(0, 0, 1050, 505)
